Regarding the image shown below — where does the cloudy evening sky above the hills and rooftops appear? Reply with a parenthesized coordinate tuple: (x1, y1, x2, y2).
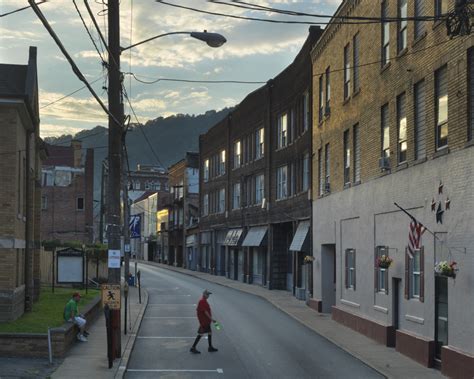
(0, 0, 341, 137)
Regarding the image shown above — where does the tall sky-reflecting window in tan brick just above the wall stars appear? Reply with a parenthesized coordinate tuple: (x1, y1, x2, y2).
(435, 66, 448, 149)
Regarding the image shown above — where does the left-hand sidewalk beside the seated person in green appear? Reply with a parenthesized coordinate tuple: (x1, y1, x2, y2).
(51, 280, 148, 379)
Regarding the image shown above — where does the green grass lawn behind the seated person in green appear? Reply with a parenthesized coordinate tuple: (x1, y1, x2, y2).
(0, 288, 100, 333)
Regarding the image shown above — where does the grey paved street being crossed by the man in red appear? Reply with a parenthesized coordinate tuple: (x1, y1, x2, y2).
(126, 265, 380, 378)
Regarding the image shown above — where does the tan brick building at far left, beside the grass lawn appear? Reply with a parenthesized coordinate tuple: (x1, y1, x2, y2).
(0, 47, 46, 322)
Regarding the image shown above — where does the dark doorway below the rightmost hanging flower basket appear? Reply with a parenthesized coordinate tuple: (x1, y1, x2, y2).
(435, 275, 448, 361)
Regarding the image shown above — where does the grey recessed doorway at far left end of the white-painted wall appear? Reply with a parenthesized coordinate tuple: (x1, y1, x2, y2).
(321, 244, 336, 313)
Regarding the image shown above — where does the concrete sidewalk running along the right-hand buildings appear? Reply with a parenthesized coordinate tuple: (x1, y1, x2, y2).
(140, 262, 444, 378)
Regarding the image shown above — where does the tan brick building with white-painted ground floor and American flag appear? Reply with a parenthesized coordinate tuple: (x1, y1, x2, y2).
(312, 0, 474, 377)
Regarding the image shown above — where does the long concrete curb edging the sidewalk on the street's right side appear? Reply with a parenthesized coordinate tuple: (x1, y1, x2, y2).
(138, 261, 393, 378)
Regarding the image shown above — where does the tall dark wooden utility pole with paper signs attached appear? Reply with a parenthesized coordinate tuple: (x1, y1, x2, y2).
(106, 0, 124, 358)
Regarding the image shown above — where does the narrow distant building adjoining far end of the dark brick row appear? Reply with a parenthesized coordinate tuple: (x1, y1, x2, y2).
(168, 152, 199, 267)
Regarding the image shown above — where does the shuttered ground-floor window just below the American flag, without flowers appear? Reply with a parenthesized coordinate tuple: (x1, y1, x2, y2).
(405, 247, 425, 302)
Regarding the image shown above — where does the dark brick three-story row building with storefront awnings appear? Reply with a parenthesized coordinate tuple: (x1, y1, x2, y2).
(198, 27, 321, 298)
